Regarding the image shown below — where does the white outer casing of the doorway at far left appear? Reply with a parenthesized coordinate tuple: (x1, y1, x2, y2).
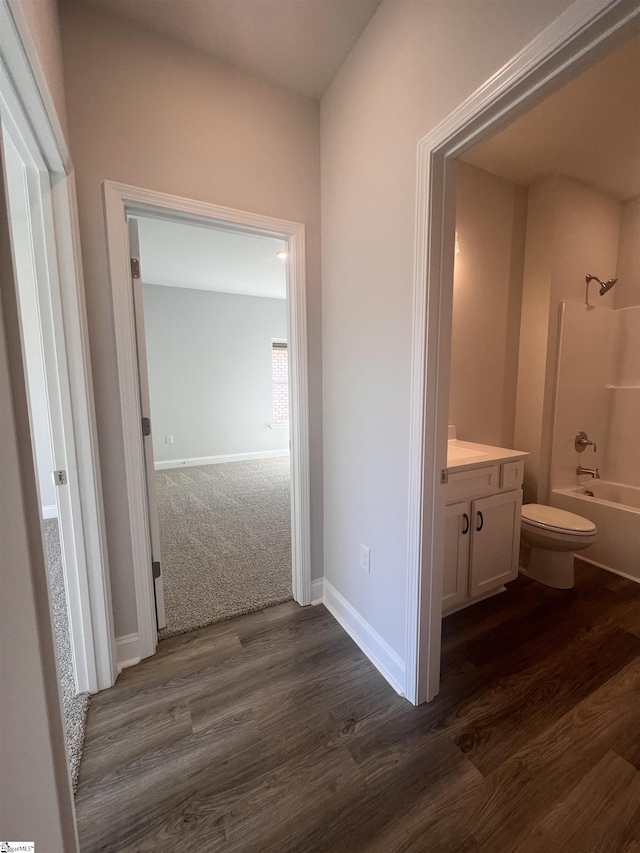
(0, 0, 117, 693)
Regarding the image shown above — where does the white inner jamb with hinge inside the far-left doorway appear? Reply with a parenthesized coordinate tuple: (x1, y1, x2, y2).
(2, 114, 113, 692)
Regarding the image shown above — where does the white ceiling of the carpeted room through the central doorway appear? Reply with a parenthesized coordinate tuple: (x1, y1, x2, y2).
(136, 216, 287, 299)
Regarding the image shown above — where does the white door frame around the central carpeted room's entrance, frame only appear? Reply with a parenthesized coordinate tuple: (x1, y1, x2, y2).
(102, 181, 311, 664)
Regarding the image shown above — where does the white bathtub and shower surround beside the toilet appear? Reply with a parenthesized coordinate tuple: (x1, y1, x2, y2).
(549, 302, 640, 581)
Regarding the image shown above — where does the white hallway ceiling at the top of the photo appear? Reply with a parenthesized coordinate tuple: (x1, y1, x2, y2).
(79, 0, 381, 98)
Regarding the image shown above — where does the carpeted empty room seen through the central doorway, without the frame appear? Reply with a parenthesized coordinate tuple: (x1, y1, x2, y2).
(138, 218, 291, 639)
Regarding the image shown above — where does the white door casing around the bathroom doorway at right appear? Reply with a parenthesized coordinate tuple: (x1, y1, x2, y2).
(405, 0, 640, 704)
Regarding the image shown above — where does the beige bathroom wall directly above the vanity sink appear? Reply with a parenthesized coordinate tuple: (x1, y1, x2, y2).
(449, 163, 527, 447)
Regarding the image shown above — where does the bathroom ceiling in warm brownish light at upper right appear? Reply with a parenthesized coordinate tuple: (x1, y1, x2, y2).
(462, 36, 640, 201)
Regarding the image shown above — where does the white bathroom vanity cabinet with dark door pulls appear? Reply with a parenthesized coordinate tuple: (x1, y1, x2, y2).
(442, 459, 524, 615)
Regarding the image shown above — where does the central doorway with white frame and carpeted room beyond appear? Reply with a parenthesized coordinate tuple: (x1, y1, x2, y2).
(104, 182, 311, 666)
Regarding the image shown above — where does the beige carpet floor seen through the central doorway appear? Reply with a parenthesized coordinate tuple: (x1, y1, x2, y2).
(156, 457, 291, 639)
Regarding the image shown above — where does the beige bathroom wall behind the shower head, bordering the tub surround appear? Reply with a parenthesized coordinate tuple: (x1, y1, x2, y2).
(514, 176, 622, 503)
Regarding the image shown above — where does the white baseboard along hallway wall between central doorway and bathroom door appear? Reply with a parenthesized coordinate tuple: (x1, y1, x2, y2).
(320, 579, 405, 696)
